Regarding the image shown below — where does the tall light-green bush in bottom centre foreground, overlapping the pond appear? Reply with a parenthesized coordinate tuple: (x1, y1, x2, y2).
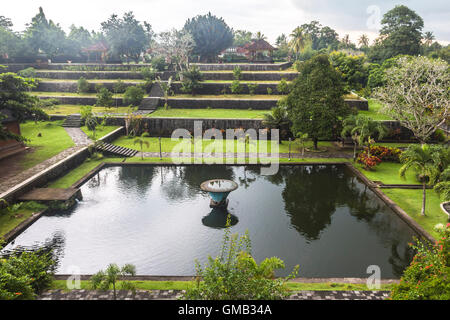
(183, 217, 298, 300)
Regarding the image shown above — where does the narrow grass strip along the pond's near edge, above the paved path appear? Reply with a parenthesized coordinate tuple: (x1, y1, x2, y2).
(50, 280, 392, 291)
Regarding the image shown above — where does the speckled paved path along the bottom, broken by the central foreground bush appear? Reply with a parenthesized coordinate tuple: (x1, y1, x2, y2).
(38, 290, 390, 300)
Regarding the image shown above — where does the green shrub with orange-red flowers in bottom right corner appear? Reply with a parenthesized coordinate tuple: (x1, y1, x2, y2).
(391, 223, 450, 300)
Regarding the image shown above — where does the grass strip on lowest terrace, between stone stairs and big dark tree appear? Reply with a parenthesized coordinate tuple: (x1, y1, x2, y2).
(149, 108, 270, 119)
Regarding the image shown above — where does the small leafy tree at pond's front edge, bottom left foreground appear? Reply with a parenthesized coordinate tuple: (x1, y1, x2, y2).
(91, 263, 136, 300)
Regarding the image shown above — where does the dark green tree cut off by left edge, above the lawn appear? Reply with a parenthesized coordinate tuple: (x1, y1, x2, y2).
(0, 72, 48, 141)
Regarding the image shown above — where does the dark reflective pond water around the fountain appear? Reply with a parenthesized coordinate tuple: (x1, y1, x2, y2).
(5, 165, 415, 279)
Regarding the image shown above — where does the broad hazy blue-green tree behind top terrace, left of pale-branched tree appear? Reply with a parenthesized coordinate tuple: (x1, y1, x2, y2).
(101, 11, 153, 62)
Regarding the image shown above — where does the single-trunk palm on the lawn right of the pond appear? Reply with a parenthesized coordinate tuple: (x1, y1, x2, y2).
(399, 144, 440, 216)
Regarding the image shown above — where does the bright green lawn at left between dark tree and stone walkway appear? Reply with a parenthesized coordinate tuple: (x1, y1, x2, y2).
(20, 121, 75, 169)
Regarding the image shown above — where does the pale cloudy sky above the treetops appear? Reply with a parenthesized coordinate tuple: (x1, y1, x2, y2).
(0, 0, 450, 44)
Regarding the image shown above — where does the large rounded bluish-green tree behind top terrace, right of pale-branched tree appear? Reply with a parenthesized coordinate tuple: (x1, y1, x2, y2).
(184, 13, 233, 62)
